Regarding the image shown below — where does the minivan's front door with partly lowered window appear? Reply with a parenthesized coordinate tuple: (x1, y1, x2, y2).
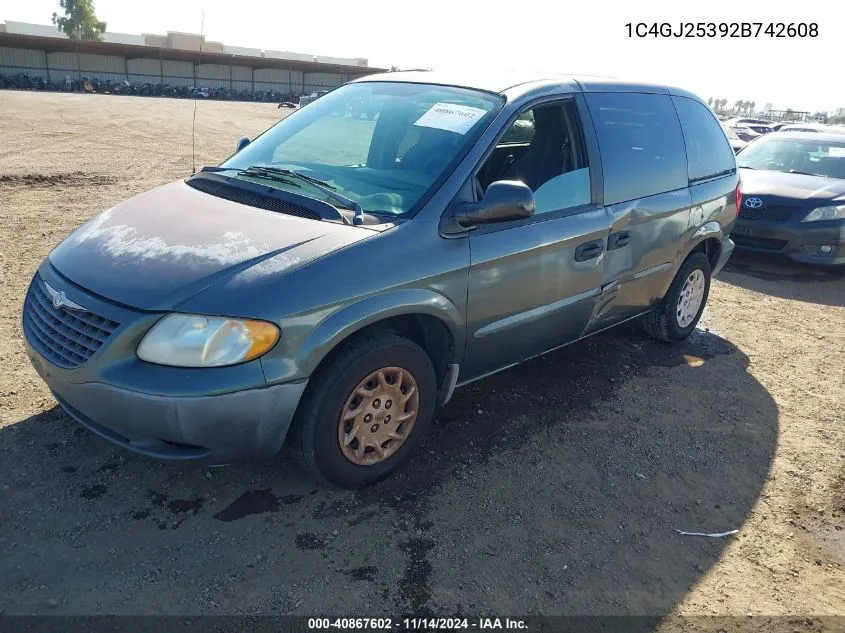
(461, 99, 610, 381)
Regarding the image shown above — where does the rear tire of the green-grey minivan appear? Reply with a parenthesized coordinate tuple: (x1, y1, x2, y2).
(642, 252, 711, 343)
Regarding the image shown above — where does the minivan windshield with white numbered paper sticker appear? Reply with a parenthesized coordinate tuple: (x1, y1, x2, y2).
(221, 82, 503, 217)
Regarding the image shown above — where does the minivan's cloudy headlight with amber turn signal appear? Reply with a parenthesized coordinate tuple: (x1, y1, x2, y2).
(138, 314, 279, 367)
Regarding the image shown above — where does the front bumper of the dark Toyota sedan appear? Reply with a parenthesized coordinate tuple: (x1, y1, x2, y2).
(731, 217, 845, 265)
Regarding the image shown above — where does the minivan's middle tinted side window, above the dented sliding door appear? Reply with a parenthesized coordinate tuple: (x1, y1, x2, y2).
(585, 92, 689, 204)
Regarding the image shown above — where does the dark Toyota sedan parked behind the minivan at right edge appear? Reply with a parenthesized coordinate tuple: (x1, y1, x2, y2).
(732, 131, 845, 270)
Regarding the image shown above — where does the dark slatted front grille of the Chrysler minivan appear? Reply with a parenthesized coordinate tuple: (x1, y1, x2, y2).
(23, 277, 120, 369)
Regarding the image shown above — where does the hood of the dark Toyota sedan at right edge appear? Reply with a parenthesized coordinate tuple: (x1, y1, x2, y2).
(739, 169, 845, 206)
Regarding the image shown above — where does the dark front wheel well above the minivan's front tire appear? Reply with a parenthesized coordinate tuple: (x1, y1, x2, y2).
(317, 314, 455, 387)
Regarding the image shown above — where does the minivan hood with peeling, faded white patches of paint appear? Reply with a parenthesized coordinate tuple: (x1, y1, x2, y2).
(49, 181, 376, 316)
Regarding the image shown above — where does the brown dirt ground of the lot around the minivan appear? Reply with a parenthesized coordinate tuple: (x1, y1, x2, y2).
(0, 92, 845, 630)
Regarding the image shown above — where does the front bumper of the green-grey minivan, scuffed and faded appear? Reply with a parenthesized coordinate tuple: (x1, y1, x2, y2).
(23, 264, 307, 464)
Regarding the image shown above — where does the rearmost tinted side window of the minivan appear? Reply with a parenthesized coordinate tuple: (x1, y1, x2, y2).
(672, 97, 736, 180)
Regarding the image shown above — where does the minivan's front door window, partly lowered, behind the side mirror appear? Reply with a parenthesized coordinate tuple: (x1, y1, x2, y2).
(478, 101, 590, 214)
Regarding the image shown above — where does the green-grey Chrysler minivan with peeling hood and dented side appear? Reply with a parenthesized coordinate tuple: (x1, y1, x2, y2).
(23, 72, 738, 487)
